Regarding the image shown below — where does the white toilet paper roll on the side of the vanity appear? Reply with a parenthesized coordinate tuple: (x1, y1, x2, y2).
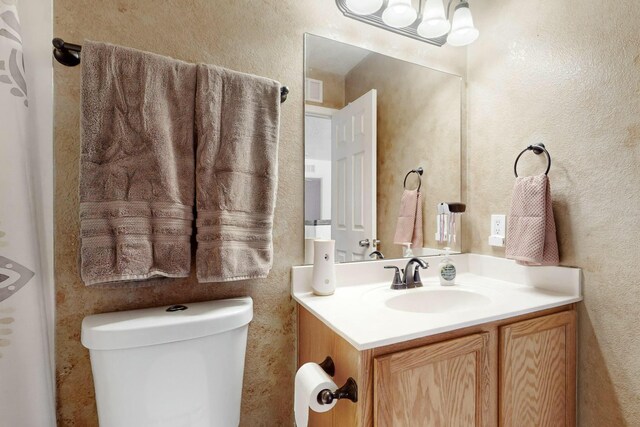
(293, 363, 338, 427)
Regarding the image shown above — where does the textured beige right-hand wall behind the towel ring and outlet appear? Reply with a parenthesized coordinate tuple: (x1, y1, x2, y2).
(467, 0, 640, 427)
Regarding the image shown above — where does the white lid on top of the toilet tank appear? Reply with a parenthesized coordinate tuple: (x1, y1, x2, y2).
(81, 297, 253, 350)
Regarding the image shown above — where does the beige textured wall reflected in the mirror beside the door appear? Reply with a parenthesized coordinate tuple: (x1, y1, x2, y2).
(345, 55, 462, 258)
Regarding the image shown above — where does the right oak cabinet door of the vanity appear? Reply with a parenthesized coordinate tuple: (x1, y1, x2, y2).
(500, 311, 576, 427)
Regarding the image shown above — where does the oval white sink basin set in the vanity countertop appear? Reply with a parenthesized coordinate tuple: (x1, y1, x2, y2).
(385, 289, 491, 313)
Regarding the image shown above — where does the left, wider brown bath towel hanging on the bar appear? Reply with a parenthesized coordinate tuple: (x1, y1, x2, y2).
(80, 41, 196, 285)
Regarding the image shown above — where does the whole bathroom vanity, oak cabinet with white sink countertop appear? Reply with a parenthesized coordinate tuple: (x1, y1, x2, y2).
(292, 254, 581, 426)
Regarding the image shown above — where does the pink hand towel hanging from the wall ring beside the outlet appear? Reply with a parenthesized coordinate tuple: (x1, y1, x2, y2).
(506, 174, 560, 265)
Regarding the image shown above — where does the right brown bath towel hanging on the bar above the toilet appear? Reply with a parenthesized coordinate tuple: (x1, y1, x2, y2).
(196, 65, 280, 282)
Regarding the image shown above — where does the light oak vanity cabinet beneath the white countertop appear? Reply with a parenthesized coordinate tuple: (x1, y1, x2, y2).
(298, 305, 576, 427)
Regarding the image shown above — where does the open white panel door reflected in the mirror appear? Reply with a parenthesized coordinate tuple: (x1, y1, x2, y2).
(331, 89, 376, 262)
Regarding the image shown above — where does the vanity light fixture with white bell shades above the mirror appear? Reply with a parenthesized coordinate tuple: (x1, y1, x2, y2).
(336, 0, 480, 46)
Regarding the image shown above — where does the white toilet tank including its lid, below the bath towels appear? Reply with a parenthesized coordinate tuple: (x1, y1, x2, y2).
(82, 297, 253, 427)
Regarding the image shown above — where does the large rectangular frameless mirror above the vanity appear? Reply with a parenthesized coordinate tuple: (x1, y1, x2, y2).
(304, 34, 462, 263)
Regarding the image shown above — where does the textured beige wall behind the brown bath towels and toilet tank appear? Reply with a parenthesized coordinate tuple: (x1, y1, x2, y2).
(54, 0, 465, 427)
